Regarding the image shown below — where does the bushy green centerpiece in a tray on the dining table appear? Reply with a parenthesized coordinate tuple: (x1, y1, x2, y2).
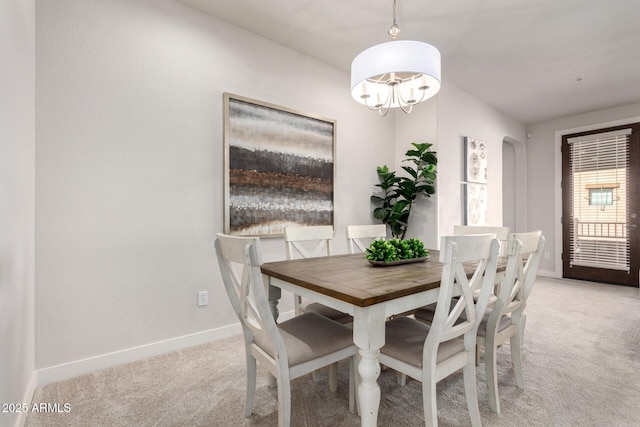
(366, 237, 429, 265)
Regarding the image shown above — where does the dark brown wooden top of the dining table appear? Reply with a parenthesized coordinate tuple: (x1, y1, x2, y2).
(261, 250, 450, 307)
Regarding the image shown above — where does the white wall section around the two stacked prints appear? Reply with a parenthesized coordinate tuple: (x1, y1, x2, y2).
(437, 83, 525, 246)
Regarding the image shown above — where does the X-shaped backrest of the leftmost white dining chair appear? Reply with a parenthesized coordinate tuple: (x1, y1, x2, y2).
(215, 233, 287, 362)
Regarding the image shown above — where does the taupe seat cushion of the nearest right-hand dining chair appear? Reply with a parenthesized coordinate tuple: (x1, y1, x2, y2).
(380, 317, 464, 368)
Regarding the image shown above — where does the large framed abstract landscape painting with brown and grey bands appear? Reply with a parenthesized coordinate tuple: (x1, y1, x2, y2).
(224, 93, 336, 237)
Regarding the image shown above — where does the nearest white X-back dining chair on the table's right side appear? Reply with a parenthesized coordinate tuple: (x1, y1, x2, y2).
(380, 234, 500, 426)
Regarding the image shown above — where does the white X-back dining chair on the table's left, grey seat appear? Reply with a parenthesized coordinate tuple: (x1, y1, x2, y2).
(215, 234, 357, 427)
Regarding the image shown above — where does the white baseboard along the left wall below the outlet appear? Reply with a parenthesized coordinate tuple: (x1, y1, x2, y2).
(37, 323, 242, 387)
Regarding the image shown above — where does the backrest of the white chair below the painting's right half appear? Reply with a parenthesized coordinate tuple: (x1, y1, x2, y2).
(284, 225, 333, 259)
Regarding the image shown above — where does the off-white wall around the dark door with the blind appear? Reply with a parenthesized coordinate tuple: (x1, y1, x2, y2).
(527, 103, 640, 277)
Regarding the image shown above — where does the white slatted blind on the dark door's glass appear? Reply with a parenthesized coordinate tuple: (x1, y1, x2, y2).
(567, 129, 631, 271)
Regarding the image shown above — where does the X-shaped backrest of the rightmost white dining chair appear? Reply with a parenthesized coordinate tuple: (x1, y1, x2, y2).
(491, 230, 544, 322)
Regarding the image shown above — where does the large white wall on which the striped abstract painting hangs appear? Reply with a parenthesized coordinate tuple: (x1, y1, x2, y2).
(35, 0, 394, 383)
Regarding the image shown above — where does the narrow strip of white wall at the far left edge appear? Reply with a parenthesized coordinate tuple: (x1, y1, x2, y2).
(0, 0, 35, 426)
